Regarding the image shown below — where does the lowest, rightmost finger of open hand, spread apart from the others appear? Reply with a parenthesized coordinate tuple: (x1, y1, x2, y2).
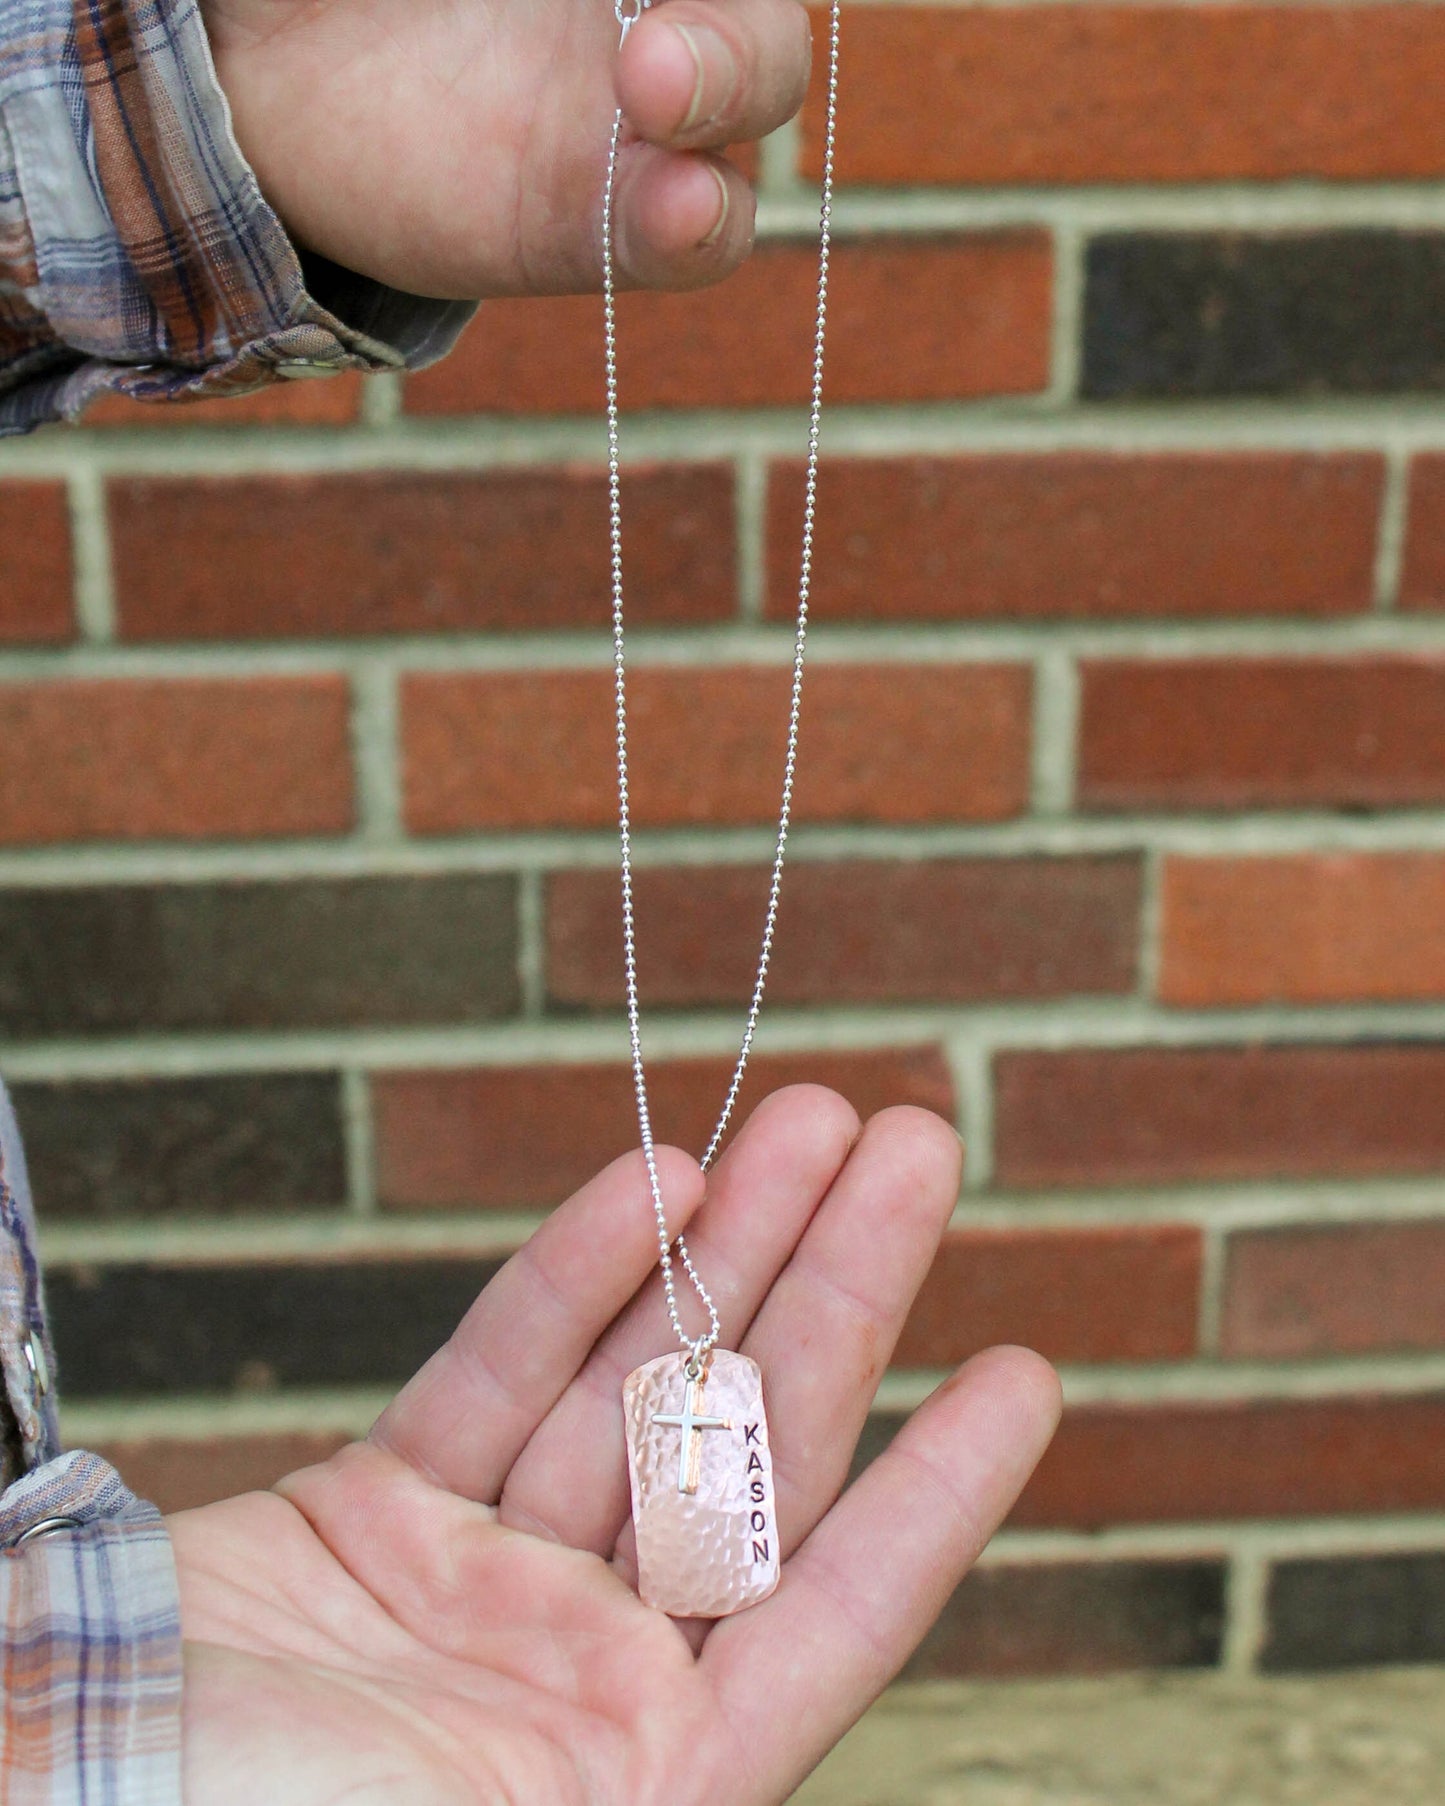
(703, 1347, 1060, 1799)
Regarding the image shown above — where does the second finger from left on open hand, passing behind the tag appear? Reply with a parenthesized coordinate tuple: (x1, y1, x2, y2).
(500, 1085, 858, 1557)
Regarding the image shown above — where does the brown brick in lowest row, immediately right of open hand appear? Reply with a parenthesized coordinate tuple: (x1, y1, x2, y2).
(900, 1560, 1225, 1681)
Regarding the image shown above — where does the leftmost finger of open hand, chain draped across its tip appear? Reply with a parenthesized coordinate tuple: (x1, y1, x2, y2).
(367, 1149, 703, 1504)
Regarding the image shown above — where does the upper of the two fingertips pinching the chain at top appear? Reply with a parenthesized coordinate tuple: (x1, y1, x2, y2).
(616, 0, 811, 150)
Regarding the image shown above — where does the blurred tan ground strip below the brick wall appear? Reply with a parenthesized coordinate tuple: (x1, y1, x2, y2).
(793, 1669, 1445, 1806)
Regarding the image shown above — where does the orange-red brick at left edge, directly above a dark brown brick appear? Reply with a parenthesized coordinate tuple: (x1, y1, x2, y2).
(0, 677, 352, 845)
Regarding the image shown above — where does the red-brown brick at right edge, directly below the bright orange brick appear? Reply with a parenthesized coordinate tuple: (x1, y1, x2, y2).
(993, 1046, 1445, 1185)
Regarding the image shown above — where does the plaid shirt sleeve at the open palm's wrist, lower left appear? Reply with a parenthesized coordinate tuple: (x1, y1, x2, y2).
(0, 1089, 181, 1806)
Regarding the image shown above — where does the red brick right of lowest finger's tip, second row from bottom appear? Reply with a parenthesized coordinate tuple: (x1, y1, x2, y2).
(1010, 1394, 1445, 1530)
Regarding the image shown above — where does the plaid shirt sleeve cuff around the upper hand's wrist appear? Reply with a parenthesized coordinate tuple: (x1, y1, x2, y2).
(0, 0, 475, 437)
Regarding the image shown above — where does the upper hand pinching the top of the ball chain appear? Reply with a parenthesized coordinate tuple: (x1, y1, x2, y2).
(200, 0, 809, 298)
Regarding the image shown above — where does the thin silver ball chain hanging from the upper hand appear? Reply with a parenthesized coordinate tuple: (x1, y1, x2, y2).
(601, 0, 842, 1378)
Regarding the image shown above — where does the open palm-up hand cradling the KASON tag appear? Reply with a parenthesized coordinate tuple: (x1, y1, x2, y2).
(170, 1087, 1058, 1806)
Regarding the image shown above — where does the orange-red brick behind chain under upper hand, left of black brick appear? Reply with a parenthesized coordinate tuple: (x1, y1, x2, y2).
(406, 231, 1053, 414)
